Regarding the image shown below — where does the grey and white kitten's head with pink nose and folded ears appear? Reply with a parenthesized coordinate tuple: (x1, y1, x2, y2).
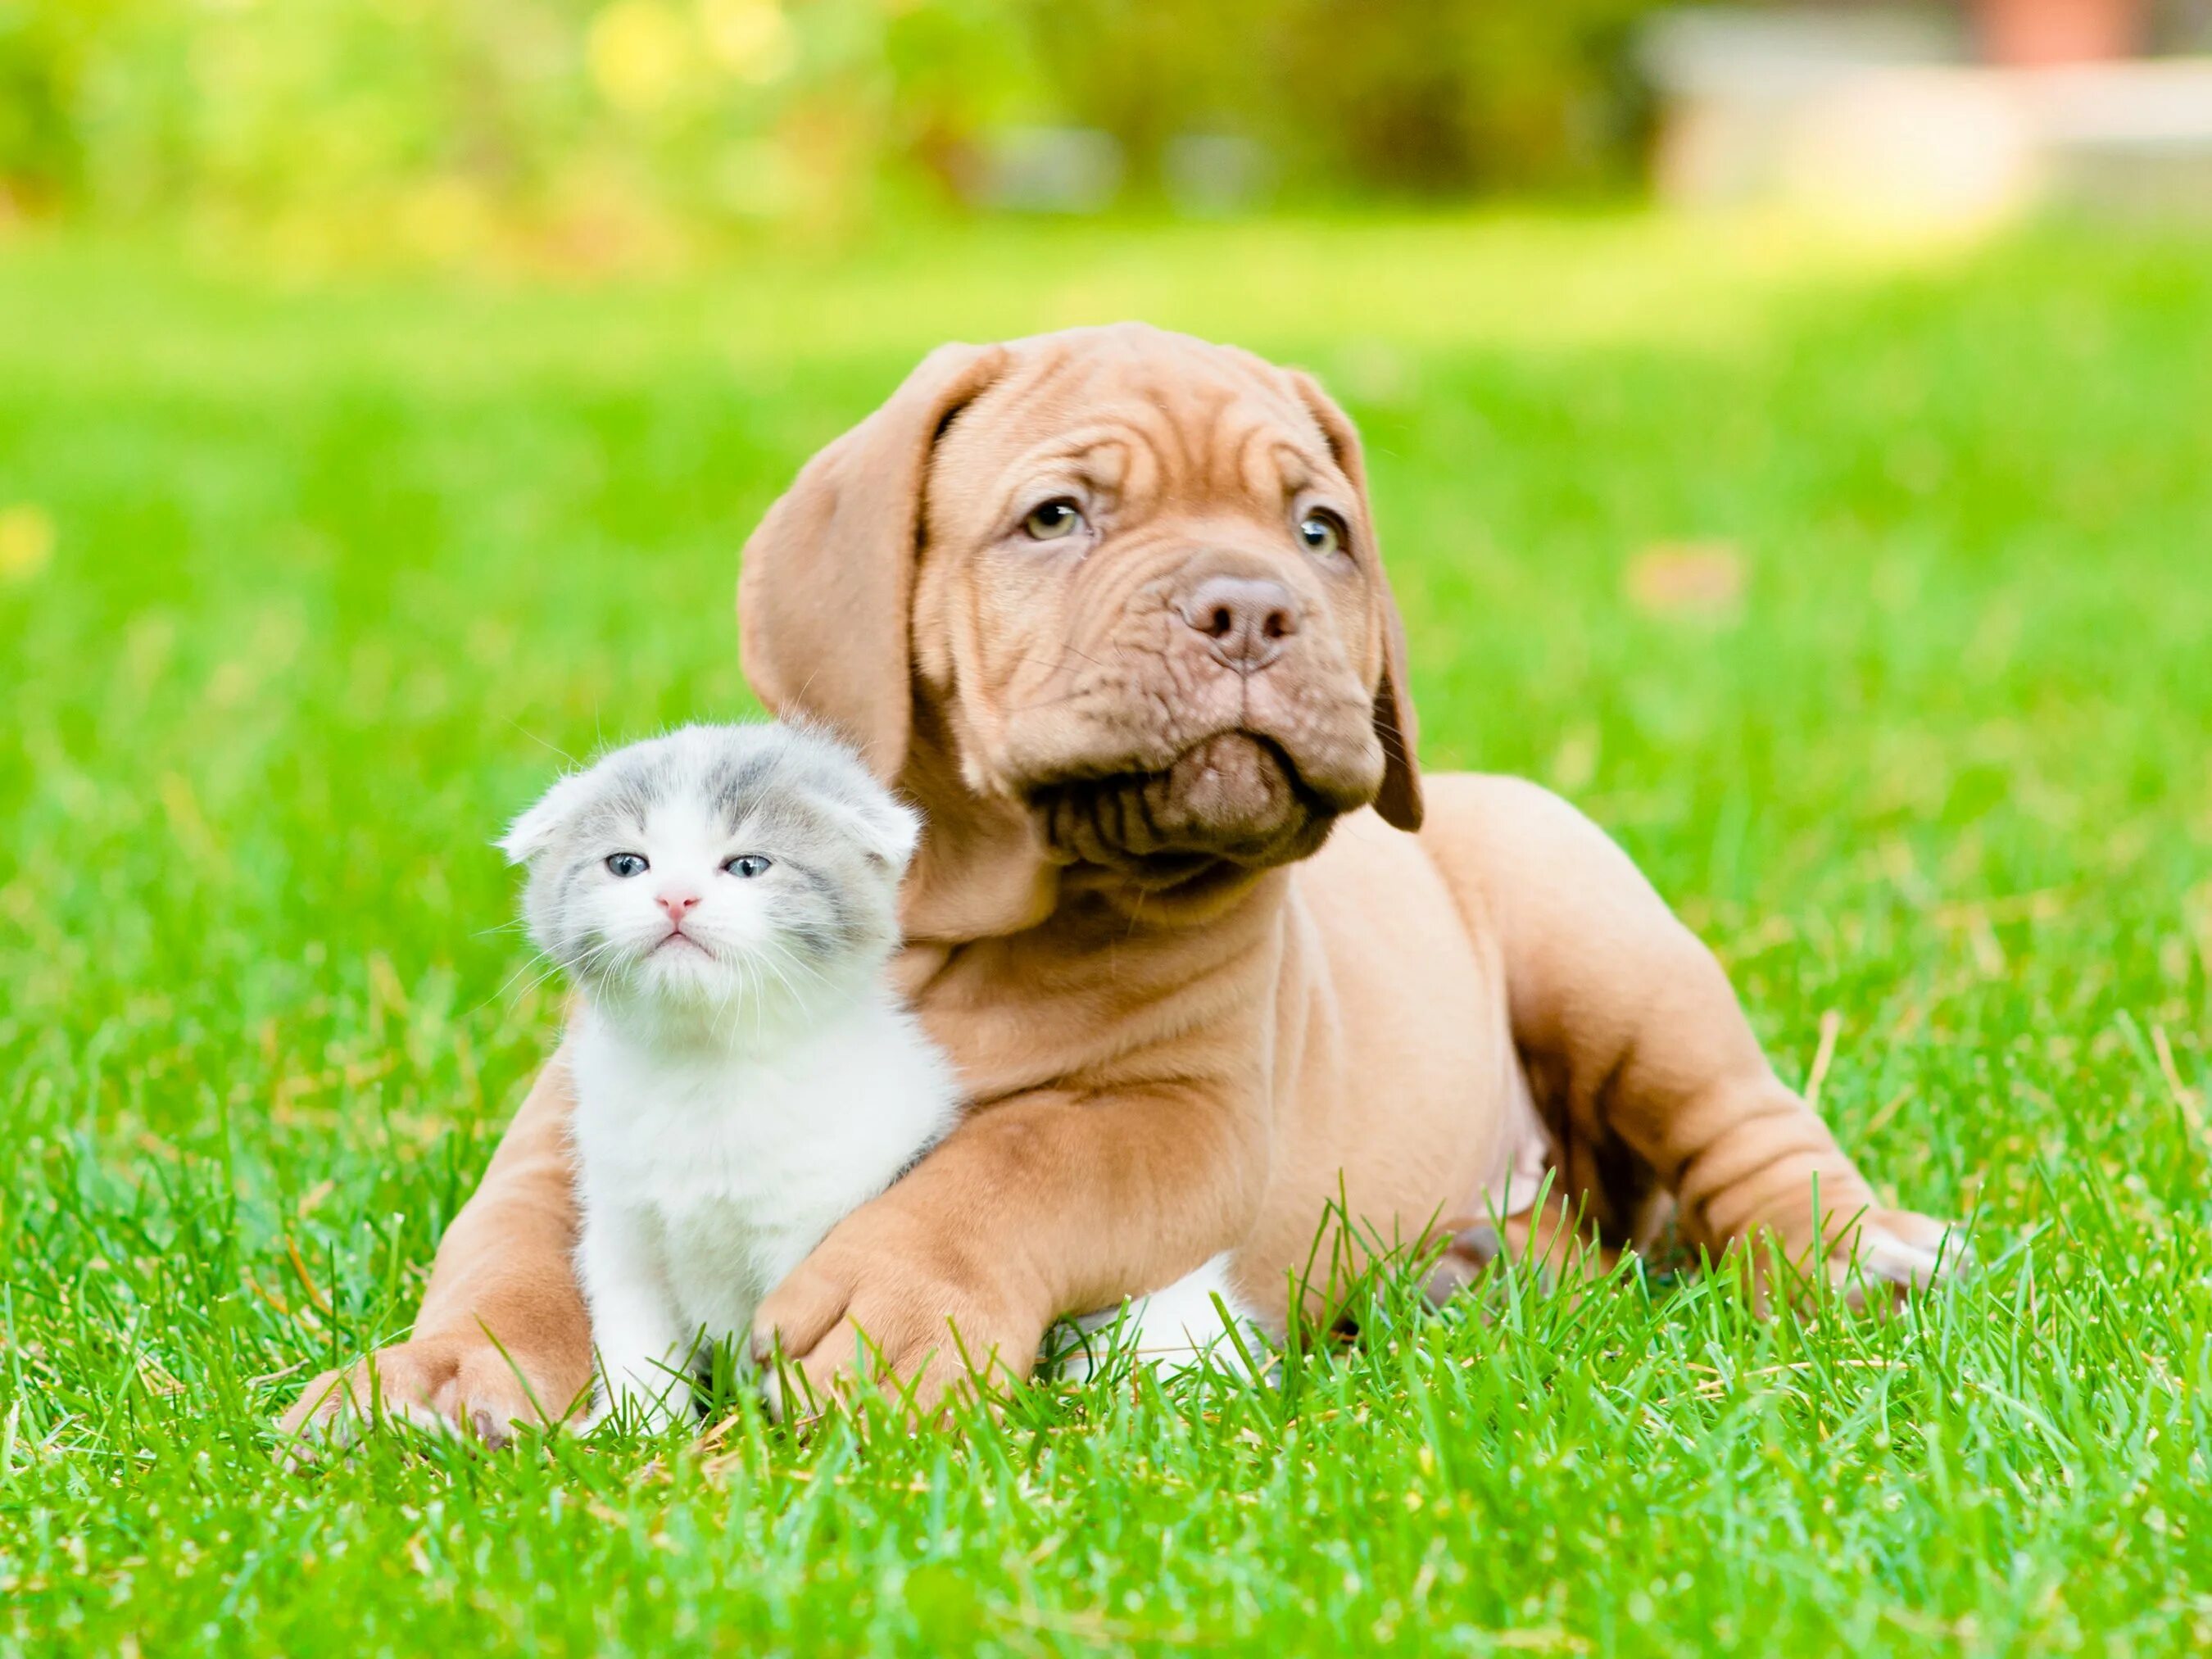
(500, 726, 920, 1009)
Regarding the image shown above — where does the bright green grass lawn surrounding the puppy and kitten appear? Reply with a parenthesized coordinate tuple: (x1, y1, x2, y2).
(0, 219, 2212, 1655)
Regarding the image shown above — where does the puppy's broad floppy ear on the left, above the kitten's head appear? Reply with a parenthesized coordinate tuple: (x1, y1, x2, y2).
(737, 345, 1007, 783)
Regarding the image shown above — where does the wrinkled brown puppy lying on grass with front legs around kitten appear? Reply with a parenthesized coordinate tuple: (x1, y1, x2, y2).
(288, 325, 1956, 1438)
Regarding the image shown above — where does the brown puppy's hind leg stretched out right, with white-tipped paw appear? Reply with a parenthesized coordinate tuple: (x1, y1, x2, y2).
(1422, 778, 1965, 1290)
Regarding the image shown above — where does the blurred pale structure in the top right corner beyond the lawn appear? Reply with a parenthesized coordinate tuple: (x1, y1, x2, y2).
(1641, 0, 2212, 228)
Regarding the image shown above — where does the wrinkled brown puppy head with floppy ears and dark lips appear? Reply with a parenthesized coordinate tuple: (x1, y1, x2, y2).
(739, 325, 1420, 911)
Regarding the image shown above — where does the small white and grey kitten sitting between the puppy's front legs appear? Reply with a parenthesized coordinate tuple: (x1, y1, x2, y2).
(500, 726, 1256, 1427)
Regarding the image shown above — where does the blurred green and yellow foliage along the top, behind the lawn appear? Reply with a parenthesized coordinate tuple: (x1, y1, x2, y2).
(0, 0, 1650, 261)
